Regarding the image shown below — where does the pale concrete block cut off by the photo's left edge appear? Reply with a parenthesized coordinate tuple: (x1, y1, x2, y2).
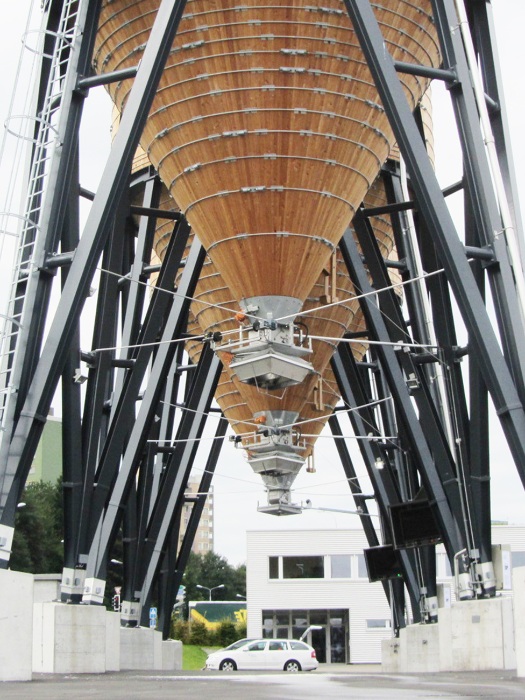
(0, 569, 33, 681)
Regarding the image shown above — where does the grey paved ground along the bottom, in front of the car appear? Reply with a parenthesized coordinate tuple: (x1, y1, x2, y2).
(0, 665, 525, 700)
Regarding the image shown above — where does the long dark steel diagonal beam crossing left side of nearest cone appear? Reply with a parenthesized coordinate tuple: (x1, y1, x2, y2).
(0, 0, 189, 566)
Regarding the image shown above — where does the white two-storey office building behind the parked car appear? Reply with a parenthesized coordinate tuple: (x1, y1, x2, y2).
(247, 525, 525, 664)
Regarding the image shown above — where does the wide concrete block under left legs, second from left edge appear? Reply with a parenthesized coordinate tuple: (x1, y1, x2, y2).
(33, 602, 120, 673)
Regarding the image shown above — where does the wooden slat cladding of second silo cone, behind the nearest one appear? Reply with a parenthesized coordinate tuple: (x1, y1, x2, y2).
(176, 175, 388, 457)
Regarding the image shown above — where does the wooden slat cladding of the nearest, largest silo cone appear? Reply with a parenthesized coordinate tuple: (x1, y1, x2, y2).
(95, 0, 439, 300)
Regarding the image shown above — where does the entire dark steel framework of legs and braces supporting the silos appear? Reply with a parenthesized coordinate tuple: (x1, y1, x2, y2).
(0, 0, 525, 632)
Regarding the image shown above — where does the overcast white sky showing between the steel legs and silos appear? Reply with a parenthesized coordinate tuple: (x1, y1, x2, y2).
(0, 0, 525, 564)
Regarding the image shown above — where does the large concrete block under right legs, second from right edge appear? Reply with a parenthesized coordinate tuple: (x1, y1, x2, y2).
(439, 597, 516, 671)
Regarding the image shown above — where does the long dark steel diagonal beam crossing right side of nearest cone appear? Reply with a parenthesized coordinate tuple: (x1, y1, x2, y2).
(345, 0, 525, 494)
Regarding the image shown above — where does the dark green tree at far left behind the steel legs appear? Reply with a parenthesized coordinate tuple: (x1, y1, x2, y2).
(10, 481, 64, 574)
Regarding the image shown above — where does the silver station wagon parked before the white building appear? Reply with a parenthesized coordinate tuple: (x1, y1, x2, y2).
(205, 639, 318, 673)
